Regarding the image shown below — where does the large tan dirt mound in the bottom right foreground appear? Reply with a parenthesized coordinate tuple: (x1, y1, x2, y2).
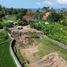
(29, 52, 67, 67)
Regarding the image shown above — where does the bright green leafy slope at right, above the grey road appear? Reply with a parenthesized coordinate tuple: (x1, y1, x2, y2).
(30, 23, 67, 45)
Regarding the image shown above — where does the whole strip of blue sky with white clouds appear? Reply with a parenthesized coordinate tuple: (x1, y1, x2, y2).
(0, 0, 67, 8)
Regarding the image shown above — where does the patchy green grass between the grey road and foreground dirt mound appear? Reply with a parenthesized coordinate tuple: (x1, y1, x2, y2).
(34, 39, 67, 60)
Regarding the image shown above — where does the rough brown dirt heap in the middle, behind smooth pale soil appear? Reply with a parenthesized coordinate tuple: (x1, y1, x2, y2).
(16, 35, 37, 49)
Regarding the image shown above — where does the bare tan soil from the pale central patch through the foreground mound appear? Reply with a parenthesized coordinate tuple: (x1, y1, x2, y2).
(20, 43, 67, 67)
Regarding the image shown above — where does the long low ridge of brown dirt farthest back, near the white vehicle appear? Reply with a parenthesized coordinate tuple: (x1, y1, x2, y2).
(11, 28, 43, 38)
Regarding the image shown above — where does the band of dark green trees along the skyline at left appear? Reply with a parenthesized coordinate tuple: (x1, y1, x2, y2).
(0, 5, 27, 19)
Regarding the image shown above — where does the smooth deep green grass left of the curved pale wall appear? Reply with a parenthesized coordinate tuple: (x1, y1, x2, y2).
(0, 32, 16, 67)
